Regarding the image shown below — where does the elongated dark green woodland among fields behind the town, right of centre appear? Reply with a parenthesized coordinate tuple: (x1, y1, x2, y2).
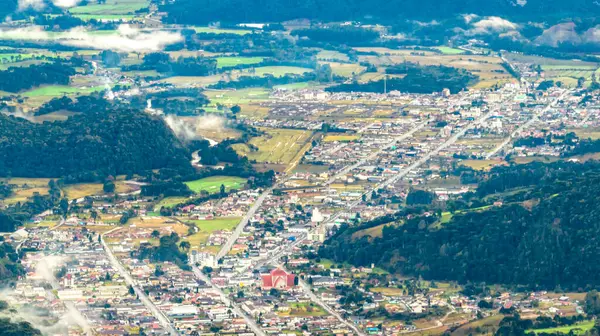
(326, 63, 478, 93)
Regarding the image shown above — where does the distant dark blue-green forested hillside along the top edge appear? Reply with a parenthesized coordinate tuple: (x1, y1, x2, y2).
(161, 0, 600, 24)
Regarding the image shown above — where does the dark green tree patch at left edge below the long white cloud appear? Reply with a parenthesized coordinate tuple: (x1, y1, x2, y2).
(0, 61, 75, 92)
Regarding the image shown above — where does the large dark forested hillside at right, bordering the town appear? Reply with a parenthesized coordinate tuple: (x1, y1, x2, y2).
(319, 163, 600, 290)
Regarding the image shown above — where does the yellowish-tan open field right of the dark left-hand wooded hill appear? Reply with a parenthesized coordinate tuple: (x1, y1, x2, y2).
(232, 128, 312, 164)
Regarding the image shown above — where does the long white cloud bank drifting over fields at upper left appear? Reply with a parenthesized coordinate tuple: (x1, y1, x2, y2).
(0, 25, 183, 52)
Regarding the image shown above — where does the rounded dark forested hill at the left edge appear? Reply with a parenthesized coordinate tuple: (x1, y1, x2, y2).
(0, 107, 192, 180)
